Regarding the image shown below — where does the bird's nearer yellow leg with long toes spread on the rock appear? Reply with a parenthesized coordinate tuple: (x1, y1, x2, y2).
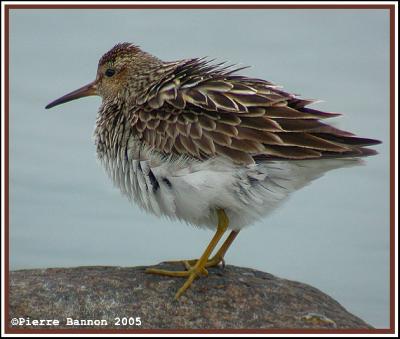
(146, 209, 229, 299)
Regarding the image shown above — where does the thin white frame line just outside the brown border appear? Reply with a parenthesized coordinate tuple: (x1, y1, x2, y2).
(1, 1, 398, 337)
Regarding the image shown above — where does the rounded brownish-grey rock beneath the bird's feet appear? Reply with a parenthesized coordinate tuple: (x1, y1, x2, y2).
(9, 263, 372, 330)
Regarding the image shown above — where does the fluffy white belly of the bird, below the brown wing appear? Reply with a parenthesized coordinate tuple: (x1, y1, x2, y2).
(95, 138, 360, 230)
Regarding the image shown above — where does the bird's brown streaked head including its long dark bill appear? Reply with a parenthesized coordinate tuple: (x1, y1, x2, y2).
(46, 43, 162, 108)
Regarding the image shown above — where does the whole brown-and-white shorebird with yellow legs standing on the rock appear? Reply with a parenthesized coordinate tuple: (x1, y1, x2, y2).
(46, 43, 380, 298)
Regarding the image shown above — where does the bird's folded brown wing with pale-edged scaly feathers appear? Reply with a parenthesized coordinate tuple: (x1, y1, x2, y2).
(132, 59, 379, 164)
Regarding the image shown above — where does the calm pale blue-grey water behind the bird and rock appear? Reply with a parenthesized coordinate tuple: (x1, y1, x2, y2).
(10, 10, 389, 327)
